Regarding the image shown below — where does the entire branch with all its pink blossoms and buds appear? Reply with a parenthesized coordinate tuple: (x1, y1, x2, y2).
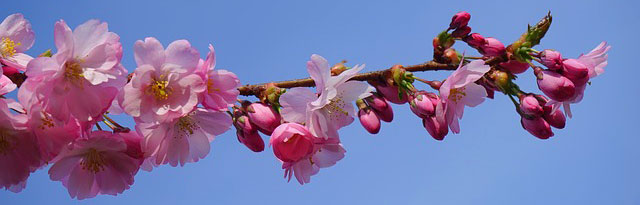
(0, 12, 610, 199)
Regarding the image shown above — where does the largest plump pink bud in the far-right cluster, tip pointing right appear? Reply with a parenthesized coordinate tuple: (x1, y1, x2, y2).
(538, 71, 576, 102)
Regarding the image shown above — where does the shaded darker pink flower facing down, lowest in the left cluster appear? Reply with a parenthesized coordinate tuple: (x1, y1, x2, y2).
(49, 131, 142, 199)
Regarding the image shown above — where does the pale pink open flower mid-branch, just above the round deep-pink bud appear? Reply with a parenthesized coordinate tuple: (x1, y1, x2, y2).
(280, 54, 373, 139)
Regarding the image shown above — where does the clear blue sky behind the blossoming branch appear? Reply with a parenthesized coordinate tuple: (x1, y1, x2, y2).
(0, 0, 640, 205)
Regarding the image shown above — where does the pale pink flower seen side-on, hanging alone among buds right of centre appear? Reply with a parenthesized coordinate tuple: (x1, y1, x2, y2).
(436, 60, 490, 133)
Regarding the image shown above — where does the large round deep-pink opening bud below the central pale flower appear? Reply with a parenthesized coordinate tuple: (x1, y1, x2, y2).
(269, 123, 315, 162)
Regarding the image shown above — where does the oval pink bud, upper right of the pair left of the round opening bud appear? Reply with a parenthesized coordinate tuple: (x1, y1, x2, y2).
(247, 103, 281, 135)
